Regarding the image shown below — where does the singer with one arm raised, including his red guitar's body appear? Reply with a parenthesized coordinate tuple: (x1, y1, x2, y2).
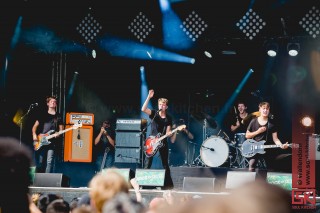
(141, 90, 179, 189)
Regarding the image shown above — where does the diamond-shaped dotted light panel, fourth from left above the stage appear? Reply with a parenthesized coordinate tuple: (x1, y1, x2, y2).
(236, 9, 266, 40)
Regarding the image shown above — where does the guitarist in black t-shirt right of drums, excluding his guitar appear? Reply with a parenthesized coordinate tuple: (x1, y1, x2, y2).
(246, 102, 289, 171)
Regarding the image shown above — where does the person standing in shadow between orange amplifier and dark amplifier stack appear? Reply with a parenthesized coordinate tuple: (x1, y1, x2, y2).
(94, 120, 116, 172)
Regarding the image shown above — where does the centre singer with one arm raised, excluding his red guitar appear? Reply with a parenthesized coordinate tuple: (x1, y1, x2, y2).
(141, 90, 173, 189)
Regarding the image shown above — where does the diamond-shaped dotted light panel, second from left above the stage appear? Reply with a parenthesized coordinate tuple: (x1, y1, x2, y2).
(128, 12, 154, 42)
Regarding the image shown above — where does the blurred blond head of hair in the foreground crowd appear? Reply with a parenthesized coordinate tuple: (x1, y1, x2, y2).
(89, 168, 129, 213)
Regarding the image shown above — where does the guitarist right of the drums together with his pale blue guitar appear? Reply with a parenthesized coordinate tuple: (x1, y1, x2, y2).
(242, 102, 289, 171)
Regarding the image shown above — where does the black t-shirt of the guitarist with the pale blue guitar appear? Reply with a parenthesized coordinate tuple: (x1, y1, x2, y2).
(248, 118, 277, 144)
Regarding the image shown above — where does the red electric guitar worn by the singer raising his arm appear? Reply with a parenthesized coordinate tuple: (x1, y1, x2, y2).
(144, 125, 186, 157)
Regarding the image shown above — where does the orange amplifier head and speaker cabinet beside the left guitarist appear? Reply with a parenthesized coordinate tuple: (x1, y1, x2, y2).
(64, 112, 94, 162)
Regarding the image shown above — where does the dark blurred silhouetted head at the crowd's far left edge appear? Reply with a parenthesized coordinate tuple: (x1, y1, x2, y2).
(0, 137, 32, 213)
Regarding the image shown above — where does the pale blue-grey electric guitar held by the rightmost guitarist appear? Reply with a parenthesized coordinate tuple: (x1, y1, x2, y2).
(241, 139, 292, 158)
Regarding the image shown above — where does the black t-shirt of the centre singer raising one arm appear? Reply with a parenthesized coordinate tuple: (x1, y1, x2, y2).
(149, 110, 172, 136)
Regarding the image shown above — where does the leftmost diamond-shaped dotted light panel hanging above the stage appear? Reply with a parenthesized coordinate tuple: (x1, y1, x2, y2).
(76, 13, 102, 44)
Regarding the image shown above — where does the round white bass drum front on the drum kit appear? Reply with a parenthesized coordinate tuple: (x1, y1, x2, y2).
(200, 136, 229, 167)
